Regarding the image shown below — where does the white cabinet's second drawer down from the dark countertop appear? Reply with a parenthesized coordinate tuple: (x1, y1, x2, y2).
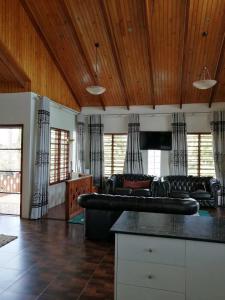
(117, 260, 185, 293)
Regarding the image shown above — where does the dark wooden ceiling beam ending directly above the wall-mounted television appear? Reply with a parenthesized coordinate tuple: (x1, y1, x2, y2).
(145, 0, 155, 109)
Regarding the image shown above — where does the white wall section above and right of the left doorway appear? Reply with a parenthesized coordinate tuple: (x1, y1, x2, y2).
(0, 93, 35, 218)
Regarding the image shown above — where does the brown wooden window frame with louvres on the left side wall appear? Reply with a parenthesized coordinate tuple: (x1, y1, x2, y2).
(49, 127, 70, 185)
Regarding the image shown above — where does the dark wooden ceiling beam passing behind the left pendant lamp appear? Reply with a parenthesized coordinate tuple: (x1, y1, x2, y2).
(59, 0, 105, 110)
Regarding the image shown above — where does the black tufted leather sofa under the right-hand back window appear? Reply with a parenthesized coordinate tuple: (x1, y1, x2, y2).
(160, 176, 221, 207)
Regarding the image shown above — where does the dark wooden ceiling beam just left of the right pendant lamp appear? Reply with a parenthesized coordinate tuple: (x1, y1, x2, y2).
(180, 0, 190, 109)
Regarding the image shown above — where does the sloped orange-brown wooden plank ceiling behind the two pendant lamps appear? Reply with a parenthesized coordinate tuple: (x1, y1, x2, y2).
(17, 0, 225, 109)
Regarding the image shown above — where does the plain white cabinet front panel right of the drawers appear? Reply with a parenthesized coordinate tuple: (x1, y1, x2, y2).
(186, 241, 225, 300)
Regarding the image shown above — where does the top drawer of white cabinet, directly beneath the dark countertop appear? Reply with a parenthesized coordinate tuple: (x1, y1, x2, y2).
(117, 234, 185, 266)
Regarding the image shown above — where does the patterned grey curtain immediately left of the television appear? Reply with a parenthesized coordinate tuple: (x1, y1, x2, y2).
(124, 114, 143, 174)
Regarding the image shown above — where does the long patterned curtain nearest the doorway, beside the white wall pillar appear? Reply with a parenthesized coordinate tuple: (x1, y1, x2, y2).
(30, 97, 50, 219)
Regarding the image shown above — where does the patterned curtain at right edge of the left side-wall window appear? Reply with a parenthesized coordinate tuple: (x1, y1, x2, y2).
(75, 115, 85, 173)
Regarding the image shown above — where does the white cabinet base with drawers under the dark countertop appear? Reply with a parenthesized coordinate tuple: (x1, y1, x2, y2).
(115, 234, 225, 300)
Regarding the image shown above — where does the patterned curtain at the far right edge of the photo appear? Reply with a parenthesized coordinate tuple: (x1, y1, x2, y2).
(211, 111, 225, 207)
